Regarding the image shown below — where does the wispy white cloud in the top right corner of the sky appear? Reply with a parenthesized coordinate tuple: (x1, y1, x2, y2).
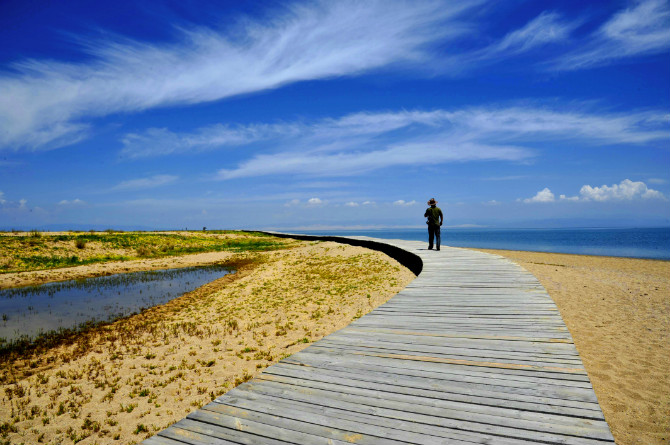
(549, 0, 670, 70)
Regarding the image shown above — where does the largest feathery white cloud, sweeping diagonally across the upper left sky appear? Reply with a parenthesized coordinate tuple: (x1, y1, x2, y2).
(0, 0, 481, 151)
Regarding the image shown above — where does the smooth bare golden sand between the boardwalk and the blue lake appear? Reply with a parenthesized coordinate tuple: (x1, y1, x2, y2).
(477, 249, 670, 445)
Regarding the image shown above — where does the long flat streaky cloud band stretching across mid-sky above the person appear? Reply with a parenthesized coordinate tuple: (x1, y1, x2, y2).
(213, 106, 670, 179)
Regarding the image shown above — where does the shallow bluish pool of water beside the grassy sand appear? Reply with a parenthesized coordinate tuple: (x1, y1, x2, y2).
(0, 266, 234, 344)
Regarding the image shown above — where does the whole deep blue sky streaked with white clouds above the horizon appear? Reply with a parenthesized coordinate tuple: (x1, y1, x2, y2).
(0, 0, 670, 229)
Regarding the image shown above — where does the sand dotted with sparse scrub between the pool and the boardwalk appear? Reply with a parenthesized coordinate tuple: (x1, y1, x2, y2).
(0, 243, 415, 444)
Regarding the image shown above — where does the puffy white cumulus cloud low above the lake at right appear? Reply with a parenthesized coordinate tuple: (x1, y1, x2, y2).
(518, 179, 667, 204)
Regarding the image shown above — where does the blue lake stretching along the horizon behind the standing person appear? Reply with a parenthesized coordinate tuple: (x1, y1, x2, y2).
(300, 227, 670, 260)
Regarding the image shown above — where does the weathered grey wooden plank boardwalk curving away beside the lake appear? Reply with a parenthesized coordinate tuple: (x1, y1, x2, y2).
(144, 237, 614, 445)
